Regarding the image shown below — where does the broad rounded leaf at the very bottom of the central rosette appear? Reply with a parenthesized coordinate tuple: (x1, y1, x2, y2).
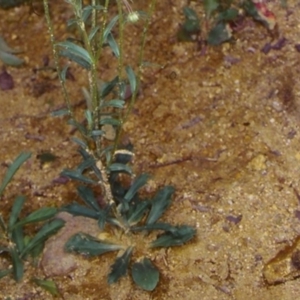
(131, 258, 159, 291)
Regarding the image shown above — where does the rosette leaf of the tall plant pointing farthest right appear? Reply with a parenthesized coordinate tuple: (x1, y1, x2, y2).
(151, 225, 196, 248)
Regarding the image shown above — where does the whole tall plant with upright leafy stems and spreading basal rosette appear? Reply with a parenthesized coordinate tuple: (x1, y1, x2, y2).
(44, 0, 195, 290)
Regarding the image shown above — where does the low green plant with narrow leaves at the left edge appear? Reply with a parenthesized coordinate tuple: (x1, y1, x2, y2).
(0, 152, 64, 281)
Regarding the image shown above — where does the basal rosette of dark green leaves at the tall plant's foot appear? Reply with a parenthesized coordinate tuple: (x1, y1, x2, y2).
(62, 149, 196, 291)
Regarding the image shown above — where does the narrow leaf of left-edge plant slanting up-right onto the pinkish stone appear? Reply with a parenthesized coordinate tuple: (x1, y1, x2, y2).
(21, 219, 65, 257)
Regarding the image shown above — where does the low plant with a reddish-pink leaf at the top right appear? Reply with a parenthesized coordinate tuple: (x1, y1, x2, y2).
(177, 0, 276, 46)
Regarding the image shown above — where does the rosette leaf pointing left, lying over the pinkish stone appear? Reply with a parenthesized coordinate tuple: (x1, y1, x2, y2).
(65, 233, 123, 256)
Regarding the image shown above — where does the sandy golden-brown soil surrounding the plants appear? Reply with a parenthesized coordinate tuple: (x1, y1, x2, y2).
(0, 0, 300, 300)
